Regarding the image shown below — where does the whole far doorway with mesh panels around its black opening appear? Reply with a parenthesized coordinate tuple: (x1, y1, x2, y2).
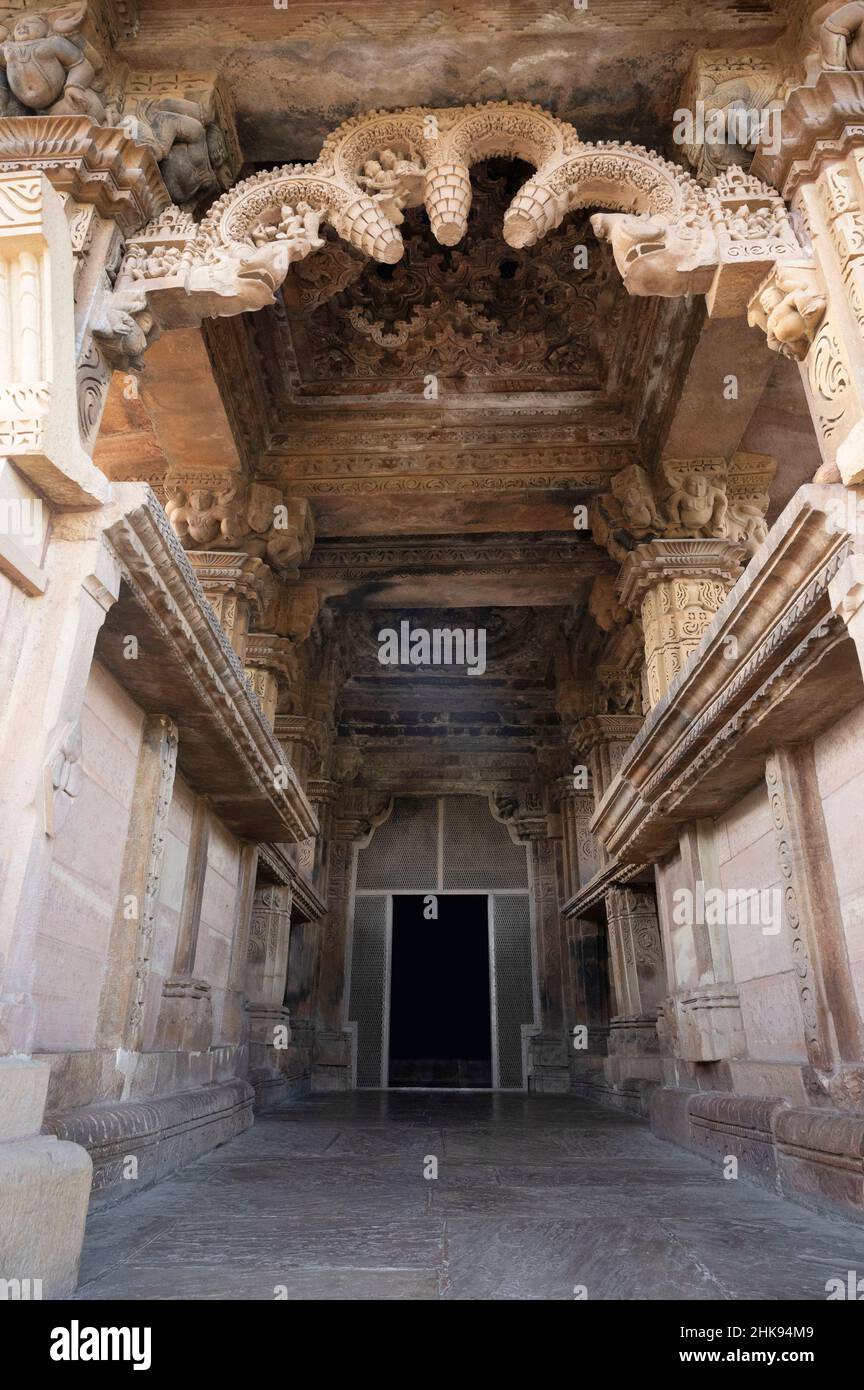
(346, 795, 539, 1090)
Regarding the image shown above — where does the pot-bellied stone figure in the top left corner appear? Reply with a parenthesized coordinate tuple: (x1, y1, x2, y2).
(0, 0, 106, 122)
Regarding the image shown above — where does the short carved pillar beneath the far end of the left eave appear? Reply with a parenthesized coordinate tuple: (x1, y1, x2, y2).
(246, 884, 292, 1105)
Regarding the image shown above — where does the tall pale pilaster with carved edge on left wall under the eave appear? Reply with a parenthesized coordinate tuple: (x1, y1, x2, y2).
(97, 714, 178, 1052)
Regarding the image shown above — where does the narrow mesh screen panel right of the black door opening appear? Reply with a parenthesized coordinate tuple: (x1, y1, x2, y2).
(492, 894, 533, 1090)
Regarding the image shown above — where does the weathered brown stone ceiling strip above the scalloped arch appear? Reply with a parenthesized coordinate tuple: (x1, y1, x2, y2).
(125, 0, 789, 163)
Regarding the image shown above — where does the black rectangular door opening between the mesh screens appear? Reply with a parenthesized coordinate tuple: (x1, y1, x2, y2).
(389, 894, 492, 1087)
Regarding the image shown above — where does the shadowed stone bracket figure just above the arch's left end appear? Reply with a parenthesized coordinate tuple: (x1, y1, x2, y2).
(121, 96, 229, 204)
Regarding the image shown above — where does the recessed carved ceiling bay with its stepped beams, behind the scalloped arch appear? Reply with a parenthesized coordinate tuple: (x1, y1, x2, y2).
(215, 160, 699, 537)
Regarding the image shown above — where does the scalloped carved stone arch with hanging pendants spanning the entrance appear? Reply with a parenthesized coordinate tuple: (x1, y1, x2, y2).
(111, 101, 804, 339)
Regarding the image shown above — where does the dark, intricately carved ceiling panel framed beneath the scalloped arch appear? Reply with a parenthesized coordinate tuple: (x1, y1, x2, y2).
(281, 163, 625, 403)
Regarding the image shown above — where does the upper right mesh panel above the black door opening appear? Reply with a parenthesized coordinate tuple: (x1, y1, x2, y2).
(445, 796, 528, 888)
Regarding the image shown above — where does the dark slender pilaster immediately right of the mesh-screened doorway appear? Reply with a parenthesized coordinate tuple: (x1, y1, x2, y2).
(528, 833, 570, 1091)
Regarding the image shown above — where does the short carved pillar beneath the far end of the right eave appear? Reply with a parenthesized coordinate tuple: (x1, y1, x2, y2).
(606, 885, 665, 1084)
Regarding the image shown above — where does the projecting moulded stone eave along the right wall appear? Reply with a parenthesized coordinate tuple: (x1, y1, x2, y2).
(592, 484, 861, 863)
